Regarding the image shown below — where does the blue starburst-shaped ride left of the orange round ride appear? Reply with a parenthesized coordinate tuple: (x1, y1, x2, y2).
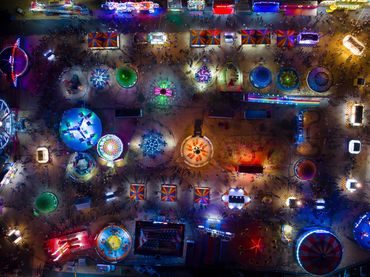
(139, 130, 167, 159)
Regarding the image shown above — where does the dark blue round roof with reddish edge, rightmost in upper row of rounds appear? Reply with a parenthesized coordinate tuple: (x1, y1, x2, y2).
(307, 67, 333, 92)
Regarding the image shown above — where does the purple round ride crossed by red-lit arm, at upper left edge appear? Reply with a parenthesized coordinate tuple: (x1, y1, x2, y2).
(0, 38, 28, 87)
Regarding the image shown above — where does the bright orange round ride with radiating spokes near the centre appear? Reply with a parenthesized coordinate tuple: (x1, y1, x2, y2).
(181, 136, 213, 167)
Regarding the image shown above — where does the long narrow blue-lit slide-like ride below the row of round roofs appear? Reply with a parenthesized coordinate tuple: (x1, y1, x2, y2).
(246, 93, 326, 107)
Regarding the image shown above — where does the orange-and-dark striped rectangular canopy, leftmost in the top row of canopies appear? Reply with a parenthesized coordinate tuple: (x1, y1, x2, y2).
(87, 32, 119, 49)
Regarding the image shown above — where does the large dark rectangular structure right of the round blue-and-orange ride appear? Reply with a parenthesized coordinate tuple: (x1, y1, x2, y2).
(134, 221, 185, 257)
